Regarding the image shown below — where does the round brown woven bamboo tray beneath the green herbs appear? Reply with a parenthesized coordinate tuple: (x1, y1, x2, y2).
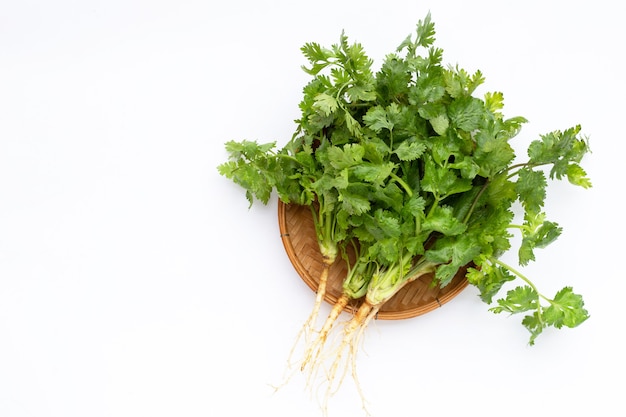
(278, 201, 468, 320)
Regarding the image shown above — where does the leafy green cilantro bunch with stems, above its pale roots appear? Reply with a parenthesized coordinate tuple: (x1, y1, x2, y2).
(219, 15, 591, 354)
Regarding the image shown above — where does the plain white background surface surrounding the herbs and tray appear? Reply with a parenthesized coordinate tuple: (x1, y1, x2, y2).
(0, 0, 626, 417)
